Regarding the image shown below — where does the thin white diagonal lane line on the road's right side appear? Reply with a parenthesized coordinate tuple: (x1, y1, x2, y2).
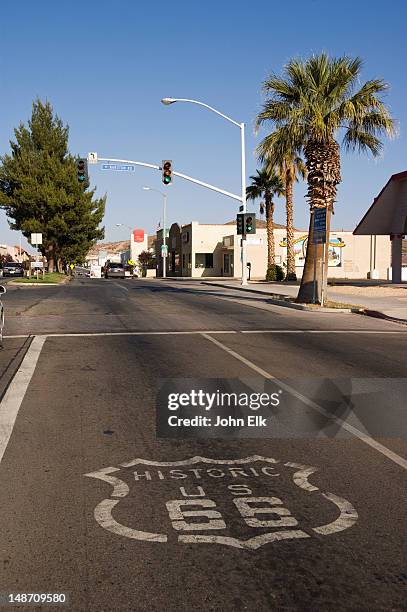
(202, 333, 407, 470)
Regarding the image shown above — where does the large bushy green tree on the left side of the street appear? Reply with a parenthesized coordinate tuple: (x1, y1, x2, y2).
(0, 99, 106, 272)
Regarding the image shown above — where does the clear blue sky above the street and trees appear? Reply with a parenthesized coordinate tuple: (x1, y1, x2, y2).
(0, 0, 407, 250)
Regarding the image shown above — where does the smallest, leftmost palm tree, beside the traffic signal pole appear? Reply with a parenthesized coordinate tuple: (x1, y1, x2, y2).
(246, 168, 284, 272)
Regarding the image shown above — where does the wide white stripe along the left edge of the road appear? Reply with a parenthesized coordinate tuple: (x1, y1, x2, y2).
(0, 336, 46, 461)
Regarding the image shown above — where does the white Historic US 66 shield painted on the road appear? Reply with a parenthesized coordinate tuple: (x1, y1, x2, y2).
(84, 455, 358, 550)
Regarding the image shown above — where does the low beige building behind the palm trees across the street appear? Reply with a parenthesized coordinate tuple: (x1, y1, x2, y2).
(156, 220, 391, 279)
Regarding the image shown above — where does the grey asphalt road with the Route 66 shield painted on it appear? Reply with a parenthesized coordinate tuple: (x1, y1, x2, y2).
(0, 279, 407, 611)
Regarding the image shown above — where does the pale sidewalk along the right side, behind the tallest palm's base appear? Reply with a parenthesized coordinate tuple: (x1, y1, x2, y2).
(202, 279, 407, 322)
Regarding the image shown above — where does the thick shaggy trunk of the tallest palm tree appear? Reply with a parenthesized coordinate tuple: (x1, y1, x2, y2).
(297, 140, 341, 304)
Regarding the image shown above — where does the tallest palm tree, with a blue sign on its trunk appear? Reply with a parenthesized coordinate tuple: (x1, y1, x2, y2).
(256, 53, 394, 302)
